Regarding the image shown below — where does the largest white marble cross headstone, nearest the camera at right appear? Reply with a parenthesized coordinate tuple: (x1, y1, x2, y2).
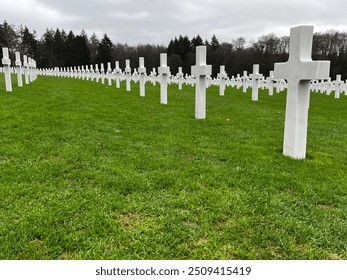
(275, 26, 330, 159)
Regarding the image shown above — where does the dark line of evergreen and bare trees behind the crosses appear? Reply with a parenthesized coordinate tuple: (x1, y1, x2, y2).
(0, 21, 347, 79)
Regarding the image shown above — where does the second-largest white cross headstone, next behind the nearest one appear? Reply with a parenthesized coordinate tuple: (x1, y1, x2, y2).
(191, 46, 212, 119)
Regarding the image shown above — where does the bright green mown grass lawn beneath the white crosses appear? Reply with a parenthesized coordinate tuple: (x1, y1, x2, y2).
(0, 74, 347, 259)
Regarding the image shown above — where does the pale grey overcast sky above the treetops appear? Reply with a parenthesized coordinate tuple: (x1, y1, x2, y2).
(0, 0, 347, 45)
